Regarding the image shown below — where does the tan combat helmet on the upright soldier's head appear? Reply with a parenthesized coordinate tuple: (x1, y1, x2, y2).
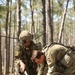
(19, 30, 33, 43)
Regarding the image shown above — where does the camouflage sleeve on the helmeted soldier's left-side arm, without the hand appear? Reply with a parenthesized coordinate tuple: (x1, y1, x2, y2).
(14, 44, 22, 75)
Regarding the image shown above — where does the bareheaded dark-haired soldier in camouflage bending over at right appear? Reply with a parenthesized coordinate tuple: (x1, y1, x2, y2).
(32, 44, 75, 75)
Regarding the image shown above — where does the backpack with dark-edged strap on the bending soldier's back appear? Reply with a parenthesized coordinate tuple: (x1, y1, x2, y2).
(42, 43, 75, 68)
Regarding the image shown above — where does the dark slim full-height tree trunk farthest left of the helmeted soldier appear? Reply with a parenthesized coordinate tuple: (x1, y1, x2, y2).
(6, 0, 9, 74)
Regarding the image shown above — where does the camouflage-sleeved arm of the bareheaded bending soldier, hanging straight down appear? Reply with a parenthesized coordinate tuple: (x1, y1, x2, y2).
(46, 49, 58, 75)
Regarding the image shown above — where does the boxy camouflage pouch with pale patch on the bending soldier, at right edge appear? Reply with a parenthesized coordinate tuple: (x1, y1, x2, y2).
(60, 50, 75, 68)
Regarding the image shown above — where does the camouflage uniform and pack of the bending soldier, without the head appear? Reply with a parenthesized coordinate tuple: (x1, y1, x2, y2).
(38, 44, 75, 75)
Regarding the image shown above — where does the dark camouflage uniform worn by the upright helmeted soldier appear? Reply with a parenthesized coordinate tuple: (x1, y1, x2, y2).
(14, 31, 42, 75)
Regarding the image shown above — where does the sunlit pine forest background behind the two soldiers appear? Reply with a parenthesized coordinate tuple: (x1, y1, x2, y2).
(0, 0, 75, 75)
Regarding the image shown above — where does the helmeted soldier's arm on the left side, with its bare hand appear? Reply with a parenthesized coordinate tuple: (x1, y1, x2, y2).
(14, 44, 25, 72)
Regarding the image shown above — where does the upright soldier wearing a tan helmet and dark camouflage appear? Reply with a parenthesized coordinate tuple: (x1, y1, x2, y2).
(14, 30, 42, 75)
